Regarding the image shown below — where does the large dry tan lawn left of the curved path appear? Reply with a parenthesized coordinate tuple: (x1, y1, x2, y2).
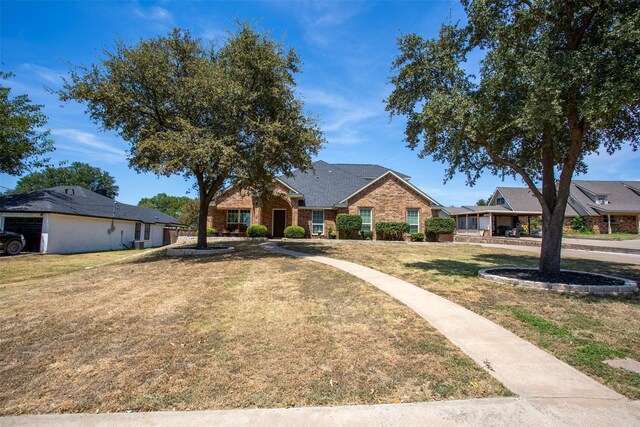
(0, 243, 509, 415)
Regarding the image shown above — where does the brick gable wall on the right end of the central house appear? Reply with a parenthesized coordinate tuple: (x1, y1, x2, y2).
(348, 175, 433, 239)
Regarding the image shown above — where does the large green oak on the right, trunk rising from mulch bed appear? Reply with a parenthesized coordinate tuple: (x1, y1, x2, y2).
(387, 0, 640, 274)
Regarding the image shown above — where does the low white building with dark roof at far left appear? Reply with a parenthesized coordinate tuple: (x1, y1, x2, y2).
(0, 186, 182, 254)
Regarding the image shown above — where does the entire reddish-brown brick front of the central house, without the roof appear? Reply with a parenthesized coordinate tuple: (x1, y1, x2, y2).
(207, 174, 434, 238)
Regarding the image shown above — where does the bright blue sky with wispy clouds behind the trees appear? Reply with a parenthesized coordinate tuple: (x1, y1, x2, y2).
(0, 0, 640, 205)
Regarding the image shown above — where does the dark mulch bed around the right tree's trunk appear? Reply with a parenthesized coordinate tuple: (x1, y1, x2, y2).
(487, 268, 625, 286)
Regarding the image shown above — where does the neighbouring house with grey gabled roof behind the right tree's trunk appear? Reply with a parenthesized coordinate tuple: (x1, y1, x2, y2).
(442, 180, 640, 236)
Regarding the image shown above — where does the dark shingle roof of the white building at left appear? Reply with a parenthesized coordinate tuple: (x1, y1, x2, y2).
(0, 186, 181, 225)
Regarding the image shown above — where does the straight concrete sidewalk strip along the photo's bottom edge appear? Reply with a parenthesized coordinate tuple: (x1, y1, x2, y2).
(0, 398, 640, 427)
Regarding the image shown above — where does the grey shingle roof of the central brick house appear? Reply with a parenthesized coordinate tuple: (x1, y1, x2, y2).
(278, 160, 439, 208)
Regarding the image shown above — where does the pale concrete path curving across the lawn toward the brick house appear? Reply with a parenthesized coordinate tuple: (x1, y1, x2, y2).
(263, 243, 626, 400)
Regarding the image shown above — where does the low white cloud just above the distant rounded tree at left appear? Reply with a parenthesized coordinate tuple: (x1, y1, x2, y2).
(51, 128, 127, 163)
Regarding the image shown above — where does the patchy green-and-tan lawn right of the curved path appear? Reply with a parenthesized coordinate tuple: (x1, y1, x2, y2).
(283, 242, 640, 399)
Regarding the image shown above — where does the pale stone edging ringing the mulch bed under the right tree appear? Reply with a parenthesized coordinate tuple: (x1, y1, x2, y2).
(478, 267, 638, 295)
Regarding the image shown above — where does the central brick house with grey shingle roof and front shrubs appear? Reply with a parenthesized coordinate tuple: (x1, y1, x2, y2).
(207, 161, 441, 237)
